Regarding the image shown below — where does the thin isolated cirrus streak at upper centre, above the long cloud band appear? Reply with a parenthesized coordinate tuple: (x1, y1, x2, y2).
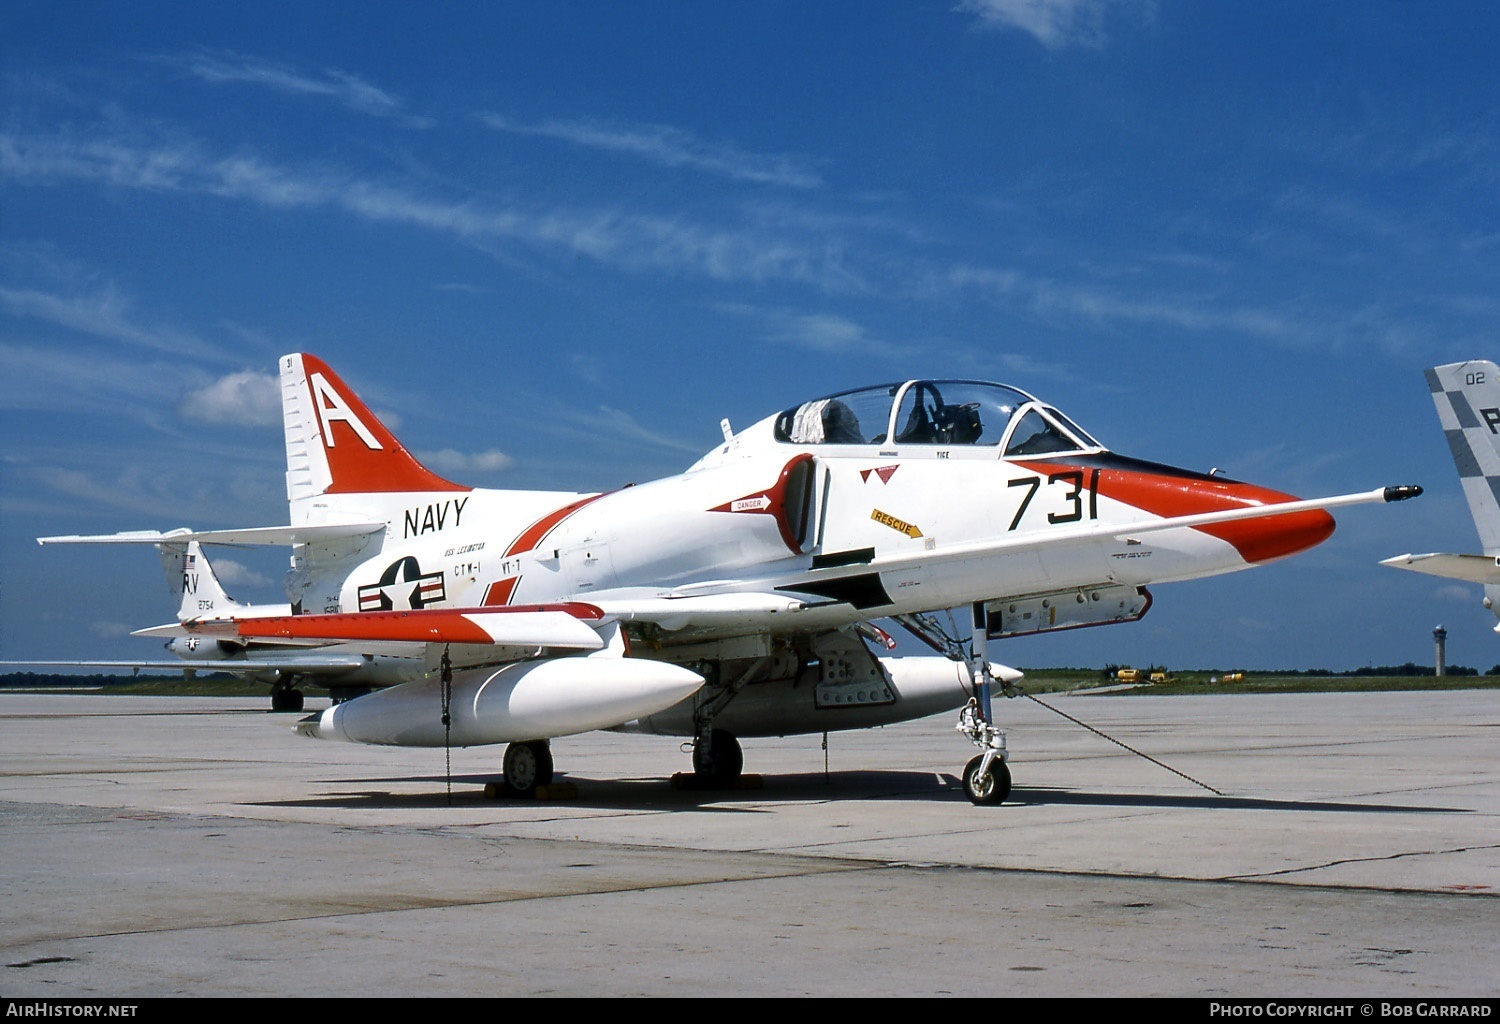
(479, 114, 824, 189)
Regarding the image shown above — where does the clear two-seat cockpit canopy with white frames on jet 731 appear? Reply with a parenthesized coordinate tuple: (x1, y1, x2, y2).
(776, 381, 1103, 459)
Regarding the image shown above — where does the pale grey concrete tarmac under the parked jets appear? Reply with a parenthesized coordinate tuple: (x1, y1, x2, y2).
(0, 691, 1500, 999)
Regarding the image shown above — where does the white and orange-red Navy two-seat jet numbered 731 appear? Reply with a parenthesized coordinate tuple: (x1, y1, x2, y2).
(32, 354, 1421, 804)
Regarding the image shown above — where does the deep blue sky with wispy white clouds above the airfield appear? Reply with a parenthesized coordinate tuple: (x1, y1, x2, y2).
(0, 0, 1500, 669)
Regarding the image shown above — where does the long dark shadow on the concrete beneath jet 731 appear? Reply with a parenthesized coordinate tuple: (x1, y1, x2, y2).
(254, 771, 1472, 814)
